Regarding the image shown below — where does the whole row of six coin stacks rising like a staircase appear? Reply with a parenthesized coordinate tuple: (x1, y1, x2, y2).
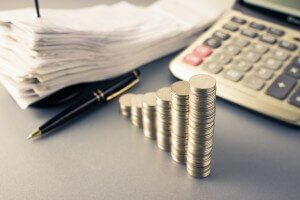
(119, 74, 216, 178)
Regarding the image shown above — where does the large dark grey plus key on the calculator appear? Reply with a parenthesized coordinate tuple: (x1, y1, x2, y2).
(267, 75, 297, 99)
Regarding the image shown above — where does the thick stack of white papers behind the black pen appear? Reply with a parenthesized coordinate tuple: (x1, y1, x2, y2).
(0, 0, 232, 109)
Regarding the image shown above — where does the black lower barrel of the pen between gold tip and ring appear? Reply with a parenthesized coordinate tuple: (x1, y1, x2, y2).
(40, 94, 102, 134)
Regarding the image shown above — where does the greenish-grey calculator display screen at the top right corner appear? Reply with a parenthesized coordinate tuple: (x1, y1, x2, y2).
(244, 0, 300, 17)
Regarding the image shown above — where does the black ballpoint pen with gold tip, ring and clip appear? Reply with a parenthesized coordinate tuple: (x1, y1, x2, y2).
(27, 70, 139, 139)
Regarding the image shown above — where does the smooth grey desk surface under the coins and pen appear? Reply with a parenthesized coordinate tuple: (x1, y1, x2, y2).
(0, 2, 300, 200)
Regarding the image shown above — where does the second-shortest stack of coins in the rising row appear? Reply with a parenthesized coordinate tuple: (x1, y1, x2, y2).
(131, 94, 143, 127)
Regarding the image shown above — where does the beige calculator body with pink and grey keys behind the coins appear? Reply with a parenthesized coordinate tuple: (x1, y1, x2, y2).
(169, 0, 300, 126)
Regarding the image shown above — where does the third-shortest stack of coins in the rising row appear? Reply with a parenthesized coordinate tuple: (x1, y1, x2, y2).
(142, 92, 156, 139)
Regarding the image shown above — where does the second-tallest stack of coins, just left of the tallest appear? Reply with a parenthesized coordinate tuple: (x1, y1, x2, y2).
(171, 81, 190, 164)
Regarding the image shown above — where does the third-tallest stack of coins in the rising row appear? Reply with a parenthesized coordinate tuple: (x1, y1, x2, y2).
(156, 87, 171, 151)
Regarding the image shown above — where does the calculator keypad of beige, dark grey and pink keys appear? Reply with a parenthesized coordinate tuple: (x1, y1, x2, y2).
(180, 17, 300, 99)
